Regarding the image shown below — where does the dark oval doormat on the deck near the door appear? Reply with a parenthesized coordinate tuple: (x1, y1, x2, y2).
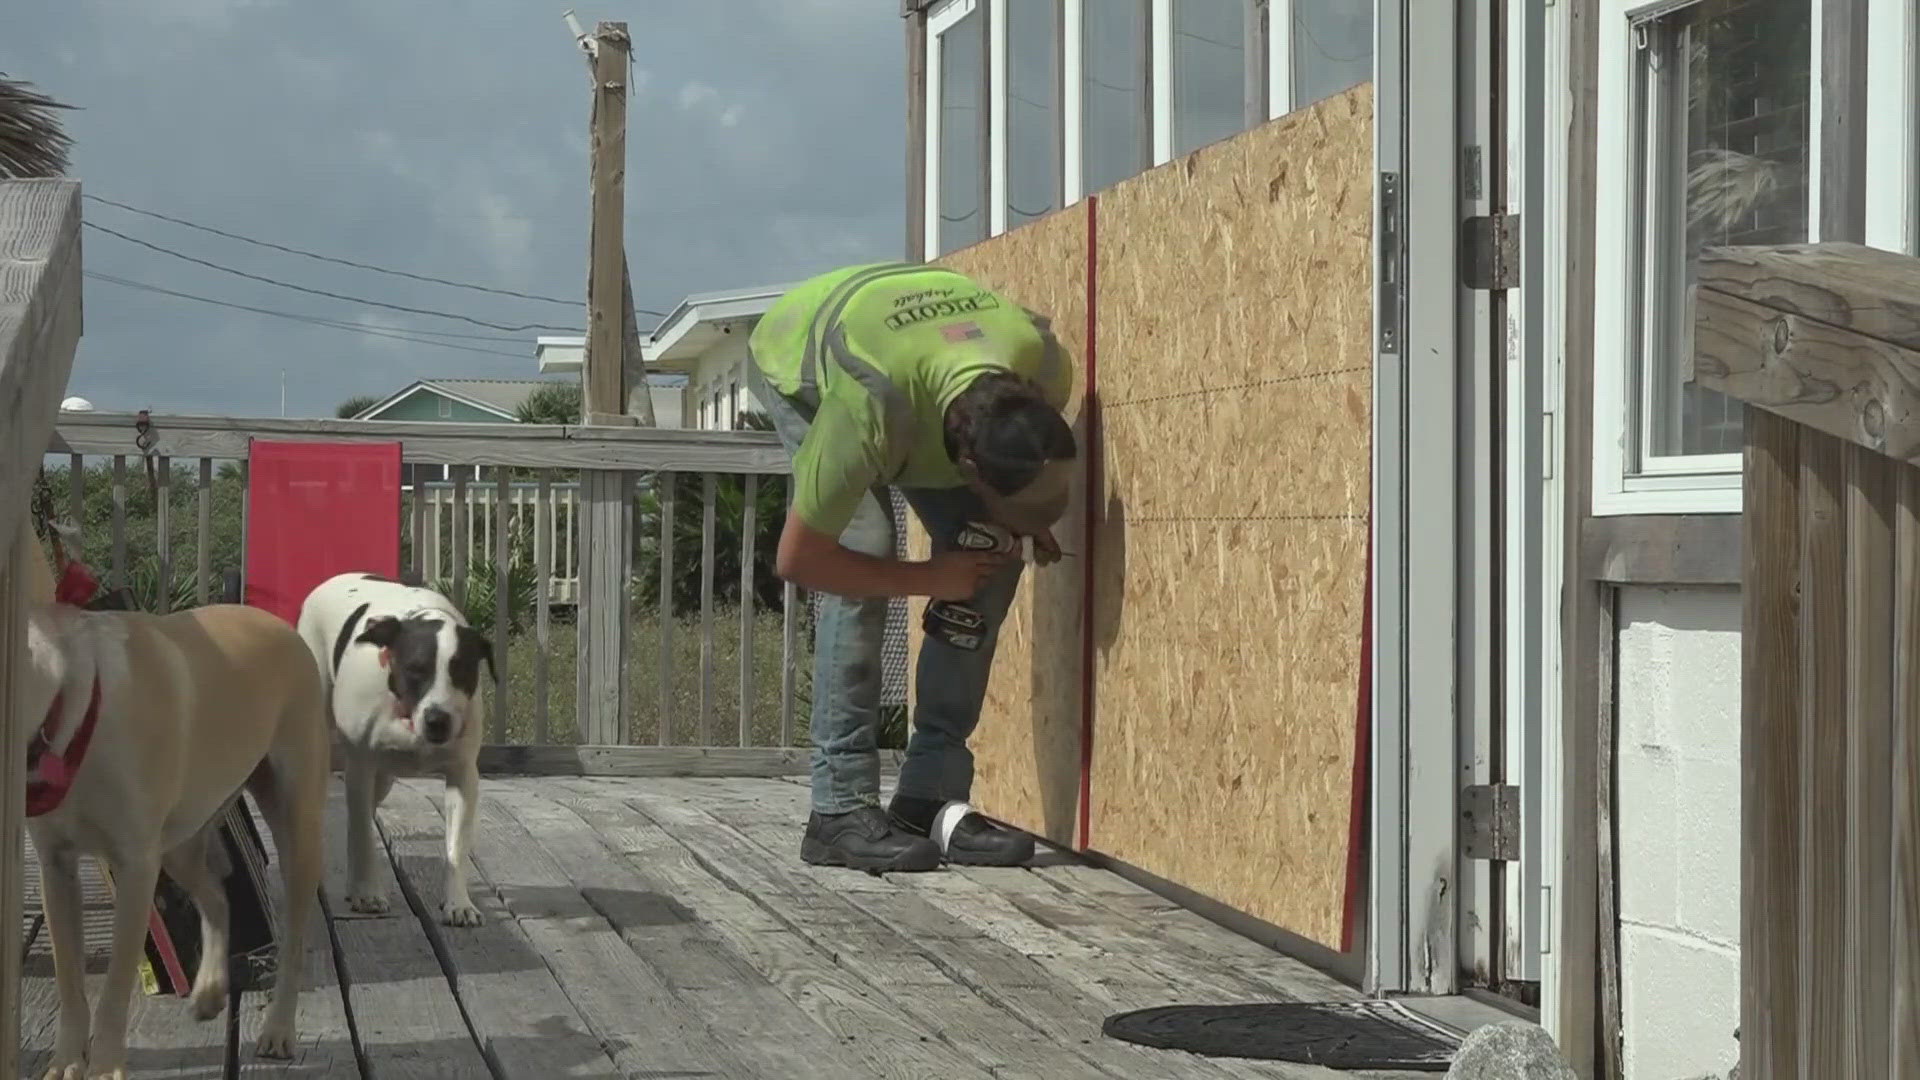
(1100, 1001, 1459, 1072)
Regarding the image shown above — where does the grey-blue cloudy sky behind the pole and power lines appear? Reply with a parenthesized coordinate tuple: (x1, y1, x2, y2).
(0, 0, 904, 415)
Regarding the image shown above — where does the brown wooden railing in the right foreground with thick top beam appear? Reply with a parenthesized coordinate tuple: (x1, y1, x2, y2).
(1693, 244, 1920, 1080)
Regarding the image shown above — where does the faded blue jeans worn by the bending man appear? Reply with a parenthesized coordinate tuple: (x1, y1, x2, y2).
(747, 361, 1021, 813)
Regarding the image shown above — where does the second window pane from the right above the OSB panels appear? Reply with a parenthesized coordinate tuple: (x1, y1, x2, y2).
(1169, 0, 1244, 156)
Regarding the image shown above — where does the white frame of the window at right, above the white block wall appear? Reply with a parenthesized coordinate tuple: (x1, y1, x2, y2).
(1589, 0, 1920, 517)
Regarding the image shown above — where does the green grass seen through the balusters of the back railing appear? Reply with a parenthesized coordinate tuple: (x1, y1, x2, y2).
(490, 607, 812, 746)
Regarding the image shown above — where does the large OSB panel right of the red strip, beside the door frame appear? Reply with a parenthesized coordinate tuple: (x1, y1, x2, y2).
(1091, 86, 1373, 947)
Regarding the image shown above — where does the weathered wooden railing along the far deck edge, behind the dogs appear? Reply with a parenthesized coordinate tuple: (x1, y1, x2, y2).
(48, 413, 833, 757)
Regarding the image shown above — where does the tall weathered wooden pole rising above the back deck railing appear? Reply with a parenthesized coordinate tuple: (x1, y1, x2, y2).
(566, 12, 659, 427)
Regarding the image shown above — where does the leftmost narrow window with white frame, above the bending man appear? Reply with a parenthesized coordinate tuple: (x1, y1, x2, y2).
(927, 0, 989, 256)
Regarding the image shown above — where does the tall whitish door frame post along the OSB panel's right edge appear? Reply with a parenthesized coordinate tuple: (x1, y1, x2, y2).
(1365, 0, 1459, 994)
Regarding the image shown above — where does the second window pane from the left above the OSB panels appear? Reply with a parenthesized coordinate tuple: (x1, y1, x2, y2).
(1004, 0, 1062, 229)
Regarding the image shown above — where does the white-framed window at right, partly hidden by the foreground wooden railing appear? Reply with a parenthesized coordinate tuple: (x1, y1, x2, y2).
(1594, 0, 1812, 513)
